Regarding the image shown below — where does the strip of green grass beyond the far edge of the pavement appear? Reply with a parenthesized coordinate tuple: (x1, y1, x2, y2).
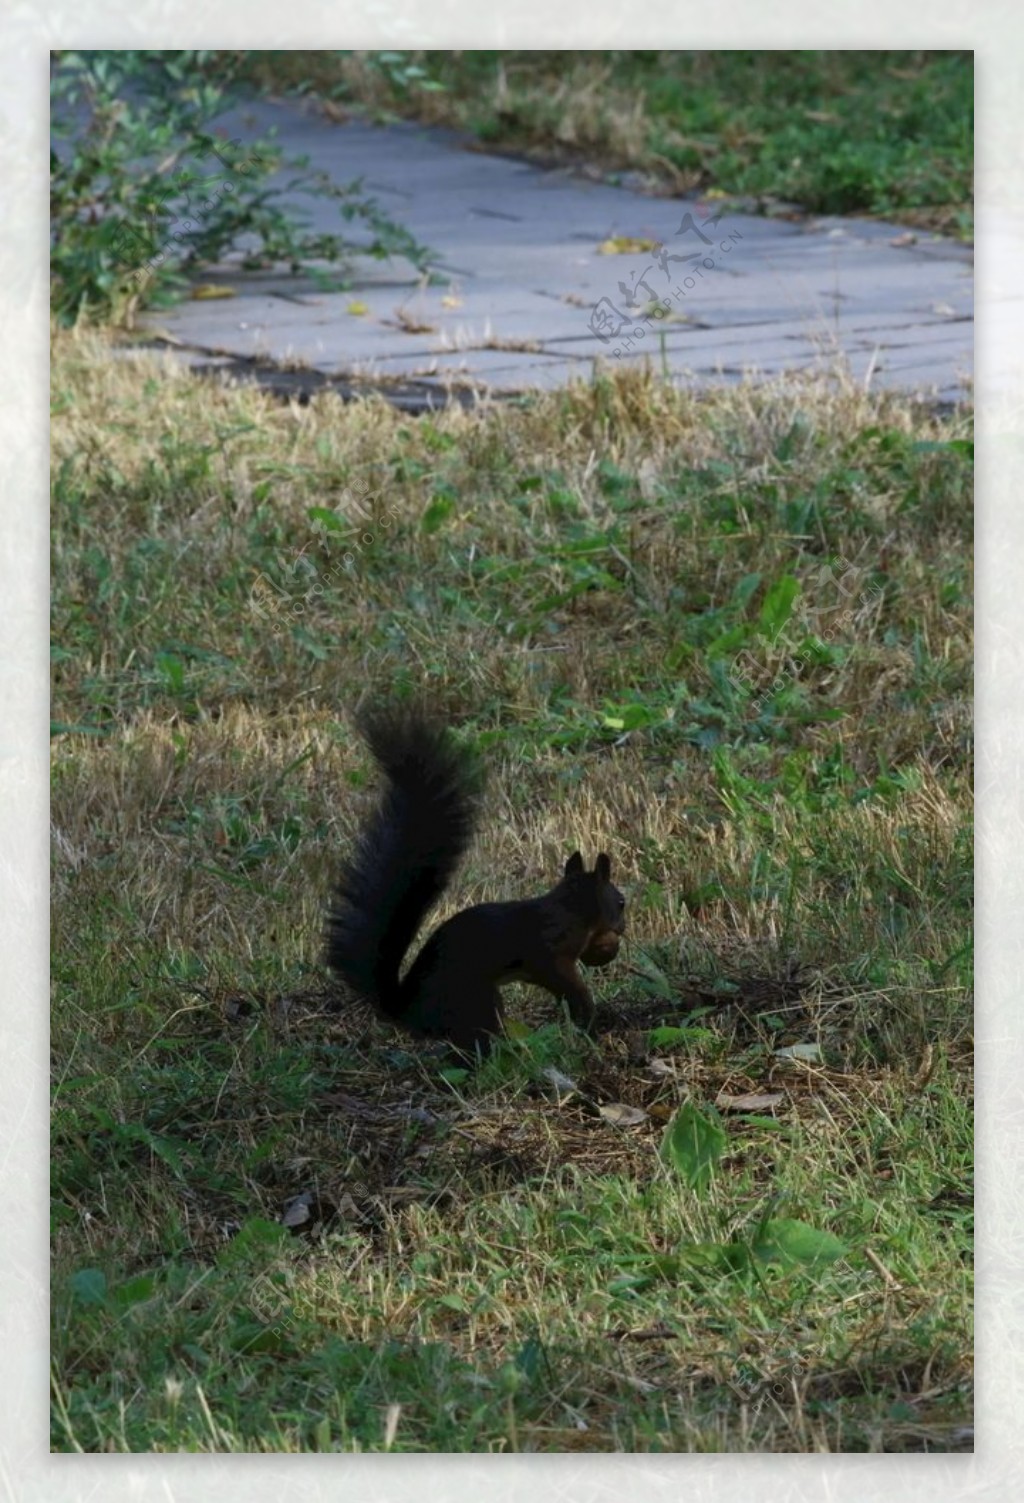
(230, 51, 974, 239)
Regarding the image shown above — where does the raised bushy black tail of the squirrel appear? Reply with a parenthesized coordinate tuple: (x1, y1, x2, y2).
(328, 705, 481, 1018)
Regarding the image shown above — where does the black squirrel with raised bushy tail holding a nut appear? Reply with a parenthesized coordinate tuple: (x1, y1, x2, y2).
(326, 705, 626, 1055)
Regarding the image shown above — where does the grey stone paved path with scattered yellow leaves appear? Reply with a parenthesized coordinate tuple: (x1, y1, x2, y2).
(131, 102, 973, 407)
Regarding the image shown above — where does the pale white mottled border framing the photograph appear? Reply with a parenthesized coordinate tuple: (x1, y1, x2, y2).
(0, 0, 1004, 1503)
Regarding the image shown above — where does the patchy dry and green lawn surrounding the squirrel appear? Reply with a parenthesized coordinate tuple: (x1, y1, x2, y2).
(53, 331, 973, 1452)
